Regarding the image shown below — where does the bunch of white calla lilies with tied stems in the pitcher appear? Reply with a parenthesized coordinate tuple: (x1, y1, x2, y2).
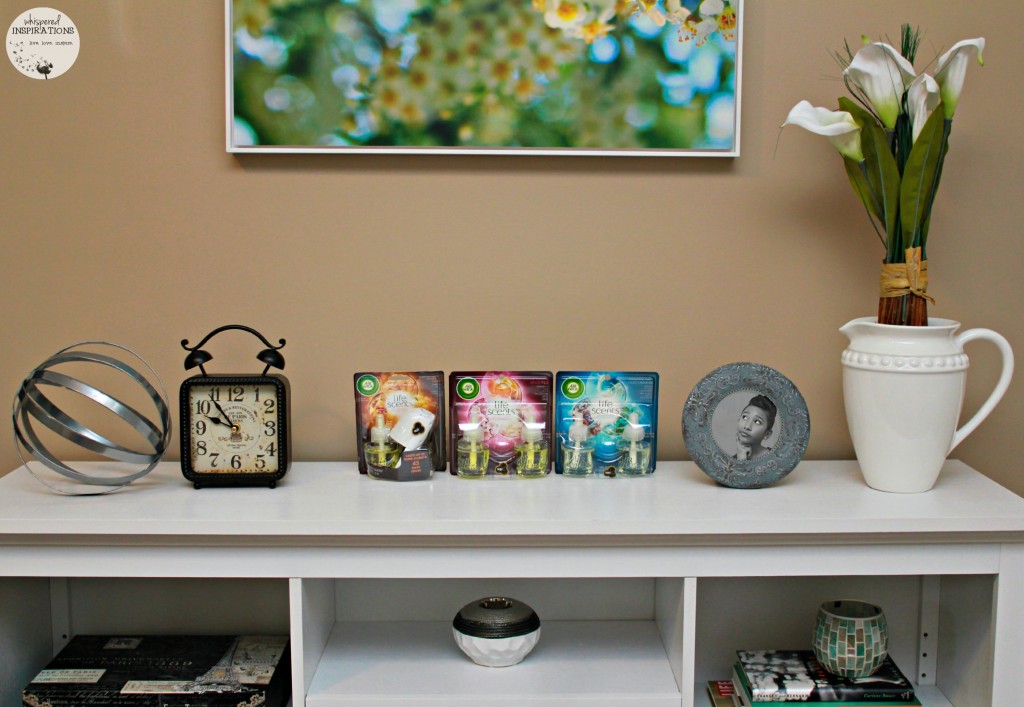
(782, 23, 985, 326)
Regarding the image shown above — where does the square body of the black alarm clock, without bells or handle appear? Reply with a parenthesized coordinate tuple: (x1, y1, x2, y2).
(182, 378, 287, 474)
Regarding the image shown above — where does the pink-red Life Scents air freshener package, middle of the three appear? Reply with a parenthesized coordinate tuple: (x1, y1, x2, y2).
(449, 371, 552, 479)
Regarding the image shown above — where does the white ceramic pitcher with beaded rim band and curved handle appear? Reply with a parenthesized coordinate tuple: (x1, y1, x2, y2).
(840, 317, 1014, 493)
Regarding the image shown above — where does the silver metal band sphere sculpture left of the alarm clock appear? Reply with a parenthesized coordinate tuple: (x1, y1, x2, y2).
(11, 341, 171, 496)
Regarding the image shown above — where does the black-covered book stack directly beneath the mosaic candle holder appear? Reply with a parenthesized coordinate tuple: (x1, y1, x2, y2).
(732, 651, 921, 707)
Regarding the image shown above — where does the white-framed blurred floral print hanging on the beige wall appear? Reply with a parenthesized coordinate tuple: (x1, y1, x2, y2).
(227, 0, 741, 156)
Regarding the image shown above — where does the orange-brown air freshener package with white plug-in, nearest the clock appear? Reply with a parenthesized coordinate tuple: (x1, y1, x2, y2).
(354, 371, 445, 482)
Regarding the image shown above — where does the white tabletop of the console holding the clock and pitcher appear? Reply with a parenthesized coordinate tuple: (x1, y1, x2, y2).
(0, 461, 1024, 544)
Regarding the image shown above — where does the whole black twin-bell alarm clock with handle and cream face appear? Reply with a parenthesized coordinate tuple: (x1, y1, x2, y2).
(180, 324, 292, 489)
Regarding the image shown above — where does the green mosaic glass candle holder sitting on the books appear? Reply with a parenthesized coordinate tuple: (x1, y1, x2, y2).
(814, 599, 889, 677)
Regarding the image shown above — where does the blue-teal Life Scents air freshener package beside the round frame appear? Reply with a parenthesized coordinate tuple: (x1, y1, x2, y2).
(555, 371, 657, 476)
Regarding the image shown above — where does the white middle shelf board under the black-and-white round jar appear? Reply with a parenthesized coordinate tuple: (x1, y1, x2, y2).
(306, 621, 681, 707)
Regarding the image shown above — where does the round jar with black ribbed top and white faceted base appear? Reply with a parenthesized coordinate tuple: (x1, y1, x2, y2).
(452, 596, 541, 668)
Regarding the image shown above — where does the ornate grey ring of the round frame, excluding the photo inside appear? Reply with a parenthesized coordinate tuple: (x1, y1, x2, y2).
(683, 363, 811, 489)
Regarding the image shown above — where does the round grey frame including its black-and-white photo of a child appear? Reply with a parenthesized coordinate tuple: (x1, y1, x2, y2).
(683, 363, 811, 489)
